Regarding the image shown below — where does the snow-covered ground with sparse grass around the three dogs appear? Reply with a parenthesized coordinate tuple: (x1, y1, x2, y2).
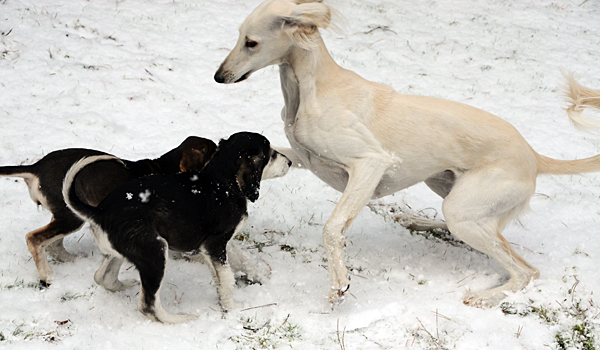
(0, 0, 600, 350)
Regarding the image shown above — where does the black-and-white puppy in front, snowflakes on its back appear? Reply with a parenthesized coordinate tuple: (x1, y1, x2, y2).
(63, 132, 291, 323)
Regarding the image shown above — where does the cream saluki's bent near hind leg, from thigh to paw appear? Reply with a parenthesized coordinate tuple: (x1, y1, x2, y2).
(442, 171, 539, 306)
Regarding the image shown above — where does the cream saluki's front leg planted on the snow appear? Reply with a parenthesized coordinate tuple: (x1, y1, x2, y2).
(323, 158, 388, 304)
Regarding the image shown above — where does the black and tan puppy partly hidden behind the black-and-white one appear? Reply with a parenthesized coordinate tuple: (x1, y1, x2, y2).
(0, 136, 216, 286)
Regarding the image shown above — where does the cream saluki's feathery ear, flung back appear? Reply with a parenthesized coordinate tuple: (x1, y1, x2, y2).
(283, 2, 331, 50)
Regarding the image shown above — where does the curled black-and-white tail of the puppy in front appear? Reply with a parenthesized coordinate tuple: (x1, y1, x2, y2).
(62, 155, 124, 224)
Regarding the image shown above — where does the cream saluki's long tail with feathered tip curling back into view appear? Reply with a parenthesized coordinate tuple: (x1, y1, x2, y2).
(538, 73, 600, 175)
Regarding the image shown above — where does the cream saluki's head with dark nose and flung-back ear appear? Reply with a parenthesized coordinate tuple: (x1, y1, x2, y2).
(215, 0, 331, 84)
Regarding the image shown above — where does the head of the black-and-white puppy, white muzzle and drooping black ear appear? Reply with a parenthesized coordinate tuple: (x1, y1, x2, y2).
(210, 132, 292, 202)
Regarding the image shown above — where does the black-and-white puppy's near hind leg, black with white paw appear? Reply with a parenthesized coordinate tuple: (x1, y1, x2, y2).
(135, 237, 196, 323)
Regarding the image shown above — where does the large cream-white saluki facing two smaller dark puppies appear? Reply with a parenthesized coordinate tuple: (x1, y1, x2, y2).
(215, 0, 600, 306)
